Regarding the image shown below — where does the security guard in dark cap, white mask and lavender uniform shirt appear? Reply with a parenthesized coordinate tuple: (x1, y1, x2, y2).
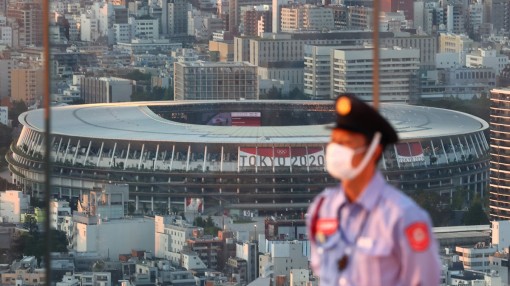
(307, 94, 440, 286)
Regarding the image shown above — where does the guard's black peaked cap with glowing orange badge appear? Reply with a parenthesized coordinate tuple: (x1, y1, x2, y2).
(333, 94, 398, 146)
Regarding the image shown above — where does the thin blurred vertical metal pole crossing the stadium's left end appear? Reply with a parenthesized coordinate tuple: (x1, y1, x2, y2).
(41, 0, 52, 286)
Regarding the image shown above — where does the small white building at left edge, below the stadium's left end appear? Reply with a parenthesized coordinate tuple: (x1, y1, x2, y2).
(0, 190, 30, 223)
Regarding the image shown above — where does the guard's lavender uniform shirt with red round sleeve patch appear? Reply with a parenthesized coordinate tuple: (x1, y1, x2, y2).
(307, 172, 441, 286)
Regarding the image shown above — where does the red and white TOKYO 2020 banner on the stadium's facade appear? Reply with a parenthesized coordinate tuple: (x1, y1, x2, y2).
(238, 147, 324, 168)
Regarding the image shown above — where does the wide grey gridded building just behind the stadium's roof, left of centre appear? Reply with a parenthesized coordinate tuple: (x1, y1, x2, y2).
(174, 62, 259, 100)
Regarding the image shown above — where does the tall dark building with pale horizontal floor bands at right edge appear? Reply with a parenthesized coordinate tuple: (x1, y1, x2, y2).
(489, 88, 510, 220)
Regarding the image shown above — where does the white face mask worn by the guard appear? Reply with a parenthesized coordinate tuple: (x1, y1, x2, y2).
(326, 132, 381, 180)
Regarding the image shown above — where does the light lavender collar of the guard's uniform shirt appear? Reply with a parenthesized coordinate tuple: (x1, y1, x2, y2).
(336, 170, 386, 211)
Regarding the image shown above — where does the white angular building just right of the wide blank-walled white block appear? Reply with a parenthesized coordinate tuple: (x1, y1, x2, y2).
(153, 216, 203, 265)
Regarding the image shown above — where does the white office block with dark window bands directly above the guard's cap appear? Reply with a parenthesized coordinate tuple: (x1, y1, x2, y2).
(331, 47, 420, 102)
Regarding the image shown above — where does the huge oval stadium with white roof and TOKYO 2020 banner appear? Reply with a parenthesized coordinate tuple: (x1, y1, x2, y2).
(6, 100, 489, 215)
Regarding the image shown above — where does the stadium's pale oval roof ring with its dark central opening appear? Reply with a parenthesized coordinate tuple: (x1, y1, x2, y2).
(20, 101, 488, 143)
